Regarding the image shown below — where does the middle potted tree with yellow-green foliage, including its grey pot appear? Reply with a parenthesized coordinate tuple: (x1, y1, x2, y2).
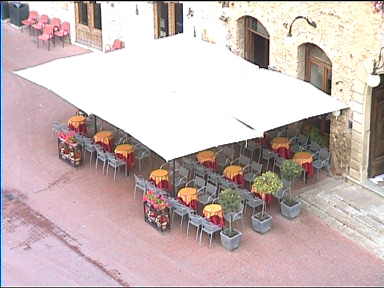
(251, 171, 283, 233)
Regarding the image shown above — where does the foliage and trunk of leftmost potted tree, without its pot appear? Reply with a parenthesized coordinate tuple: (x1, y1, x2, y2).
(218, 188, 242, 237)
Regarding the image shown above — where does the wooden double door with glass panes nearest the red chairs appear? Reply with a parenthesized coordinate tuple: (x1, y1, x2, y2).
(75, 1, 103, 50)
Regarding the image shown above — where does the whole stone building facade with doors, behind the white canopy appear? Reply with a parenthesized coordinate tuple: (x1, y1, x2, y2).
(19, 1, 384, 195)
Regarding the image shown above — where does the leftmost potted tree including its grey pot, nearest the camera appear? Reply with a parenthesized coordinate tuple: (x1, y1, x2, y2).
(218, 188, 242, 251)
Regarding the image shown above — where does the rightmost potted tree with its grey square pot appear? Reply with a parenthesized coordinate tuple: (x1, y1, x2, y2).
(280, 160, 303, 219)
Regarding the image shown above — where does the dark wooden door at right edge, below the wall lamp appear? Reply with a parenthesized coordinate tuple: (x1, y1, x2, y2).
(368, 75, 384, 178)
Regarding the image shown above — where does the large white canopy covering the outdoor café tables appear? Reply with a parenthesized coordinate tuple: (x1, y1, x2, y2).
(15, 34, 347, 161)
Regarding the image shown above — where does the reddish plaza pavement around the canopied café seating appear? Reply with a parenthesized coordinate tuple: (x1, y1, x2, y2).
(2, 25, 384, 286)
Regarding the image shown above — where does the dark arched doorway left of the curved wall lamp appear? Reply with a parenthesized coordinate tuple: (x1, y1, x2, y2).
(244, 16, 269, 69)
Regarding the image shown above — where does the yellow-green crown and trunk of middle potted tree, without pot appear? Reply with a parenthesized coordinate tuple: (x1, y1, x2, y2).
(252, 171, 283, 219)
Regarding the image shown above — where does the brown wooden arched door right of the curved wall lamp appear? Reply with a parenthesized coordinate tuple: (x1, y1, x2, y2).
(304, 43, 332, 94)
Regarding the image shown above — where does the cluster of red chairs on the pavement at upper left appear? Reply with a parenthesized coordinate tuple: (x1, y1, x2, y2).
(22, 11, 71, 50)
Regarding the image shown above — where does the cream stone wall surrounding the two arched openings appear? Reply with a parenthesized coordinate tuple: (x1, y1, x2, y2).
(214, 1, 384, 181)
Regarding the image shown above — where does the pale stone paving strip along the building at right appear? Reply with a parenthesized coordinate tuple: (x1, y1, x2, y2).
(300, 178, 384, 259)
